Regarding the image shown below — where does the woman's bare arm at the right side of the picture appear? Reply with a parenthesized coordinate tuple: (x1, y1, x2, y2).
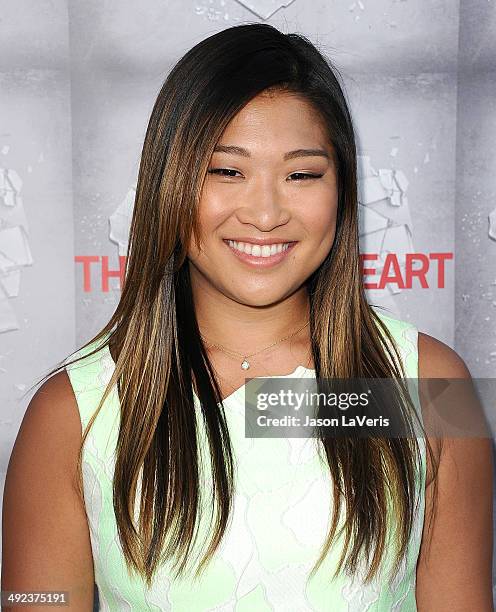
(416, 333, 493, 612)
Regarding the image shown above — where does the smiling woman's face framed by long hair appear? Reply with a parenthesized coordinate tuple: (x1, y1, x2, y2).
(188, 93, 338, 306)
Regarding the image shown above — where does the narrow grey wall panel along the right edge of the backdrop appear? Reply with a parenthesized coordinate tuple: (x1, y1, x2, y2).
(455, 1, 496, 377)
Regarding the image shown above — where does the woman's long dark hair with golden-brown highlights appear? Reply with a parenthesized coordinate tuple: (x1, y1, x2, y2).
(34, 23, 435, 585)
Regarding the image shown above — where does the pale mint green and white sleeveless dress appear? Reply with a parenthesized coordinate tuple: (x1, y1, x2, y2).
(66, 313, 426, 612)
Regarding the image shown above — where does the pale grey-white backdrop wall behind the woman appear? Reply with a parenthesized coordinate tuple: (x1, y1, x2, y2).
(0, 0, 496, 604)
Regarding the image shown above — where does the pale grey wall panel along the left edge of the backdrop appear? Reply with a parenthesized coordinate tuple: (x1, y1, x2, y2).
(0, 0, 75, 548)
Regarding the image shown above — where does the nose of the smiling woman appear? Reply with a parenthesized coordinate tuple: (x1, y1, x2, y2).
(236, 176, 291, 231)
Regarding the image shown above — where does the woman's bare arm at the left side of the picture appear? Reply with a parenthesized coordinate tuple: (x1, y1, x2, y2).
(2, 371, 94, 612)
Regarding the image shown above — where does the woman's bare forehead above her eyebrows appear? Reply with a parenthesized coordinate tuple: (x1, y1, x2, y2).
(220, 92, 330, 150)
